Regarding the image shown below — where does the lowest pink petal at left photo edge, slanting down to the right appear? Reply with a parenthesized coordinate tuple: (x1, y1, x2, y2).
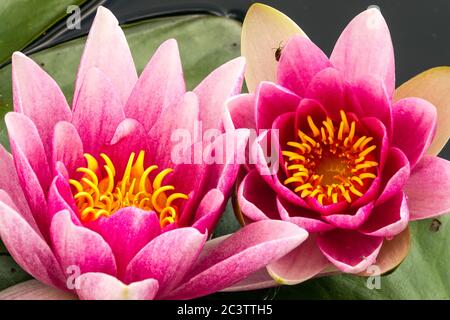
(0, 201, 64, 289)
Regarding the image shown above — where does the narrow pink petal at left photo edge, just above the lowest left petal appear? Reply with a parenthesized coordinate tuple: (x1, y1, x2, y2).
(0, 145, 36, 227)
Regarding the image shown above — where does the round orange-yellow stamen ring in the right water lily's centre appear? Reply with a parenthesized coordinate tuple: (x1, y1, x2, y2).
(282, 110, 378, 205)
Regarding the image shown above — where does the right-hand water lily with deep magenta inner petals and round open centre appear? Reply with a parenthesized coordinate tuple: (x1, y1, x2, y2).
(226, 5, 450, 289)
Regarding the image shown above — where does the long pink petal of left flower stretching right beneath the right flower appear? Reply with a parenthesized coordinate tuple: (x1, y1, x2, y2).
(167, 220, 308, 299)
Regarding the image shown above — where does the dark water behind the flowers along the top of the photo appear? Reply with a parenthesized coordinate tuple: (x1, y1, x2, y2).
(28, 0, 450, 158)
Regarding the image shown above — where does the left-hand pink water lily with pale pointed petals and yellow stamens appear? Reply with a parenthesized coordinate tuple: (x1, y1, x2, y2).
(0, 7, 307, 299)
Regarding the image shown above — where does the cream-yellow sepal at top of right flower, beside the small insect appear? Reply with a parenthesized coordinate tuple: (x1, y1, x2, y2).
(241, 3, 306, 92)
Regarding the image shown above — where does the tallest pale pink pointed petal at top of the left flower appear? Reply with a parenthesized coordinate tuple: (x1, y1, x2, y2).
(73, 6, 137, 105)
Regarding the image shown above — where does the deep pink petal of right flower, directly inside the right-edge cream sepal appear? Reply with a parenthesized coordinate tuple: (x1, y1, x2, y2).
(393, 98, 437, 168)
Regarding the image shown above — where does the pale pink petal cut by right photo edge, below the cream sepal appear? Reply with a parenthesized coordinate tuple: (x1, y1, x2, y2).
(404, 156, 450, 220)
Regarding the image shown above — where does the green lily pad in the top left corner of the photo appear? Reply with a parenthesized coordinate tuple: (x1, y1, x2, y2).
(0, 0, 86, 64)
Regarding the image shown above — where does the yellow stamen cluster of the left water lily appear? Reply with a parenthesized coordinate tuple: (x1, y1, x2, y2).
(69, 151, 188, 227)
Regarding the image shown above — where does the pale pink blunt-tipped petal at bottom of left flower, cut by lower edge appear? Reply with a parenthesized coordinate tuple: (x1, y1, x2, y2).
(77, 272, 159, 300)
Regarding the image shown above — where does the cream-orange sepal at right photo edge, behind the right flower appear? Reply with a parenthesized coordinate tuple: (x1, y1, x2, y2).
(394, 67, 450, 155)
